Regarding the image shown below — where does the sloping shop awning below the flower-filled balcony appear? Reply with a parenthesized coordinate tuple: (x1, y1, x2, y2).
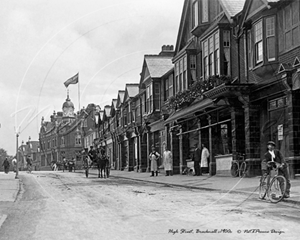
(165, 98, 215, 124)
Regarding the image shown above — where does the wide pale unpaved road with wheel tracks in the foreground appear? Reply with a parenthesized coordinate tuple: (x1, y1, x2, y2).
(0, 172, 300, 240)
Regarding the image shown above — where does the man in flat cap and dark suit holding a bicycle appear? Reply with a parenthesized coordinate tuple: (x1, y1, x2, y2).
(262, 141, 291, 198)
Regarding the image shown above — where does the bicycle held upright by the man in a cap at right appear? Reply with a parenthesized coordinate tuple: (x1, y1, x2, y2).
(259, 161, 287, 203)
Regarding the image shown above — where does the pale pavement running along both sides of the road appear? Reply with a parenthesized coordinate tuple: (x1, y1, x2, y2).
(0, 169, 300, 204)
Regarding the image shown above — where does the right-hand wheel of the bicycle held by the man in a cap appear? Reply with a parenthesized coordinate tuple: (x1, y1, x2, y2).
(268, 176, 286, 203)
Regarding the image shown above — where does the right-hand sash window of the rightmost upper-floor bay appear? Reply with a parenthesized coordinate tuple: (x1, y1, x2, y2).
(266, 17, 275, 61)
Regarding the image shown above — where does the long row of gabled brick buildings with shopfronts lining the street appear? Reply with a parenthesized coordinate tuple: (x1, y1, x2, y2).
(40, 0, 300, 177)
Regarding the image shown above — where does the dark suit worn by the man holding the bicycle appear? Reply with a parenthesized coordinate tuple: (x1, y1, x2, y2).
(261, 149, 291, 194)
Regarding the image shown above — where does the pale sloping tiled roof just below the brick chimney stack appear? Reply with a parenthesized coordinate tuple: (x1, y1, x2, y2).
(145, 55, 173, 78)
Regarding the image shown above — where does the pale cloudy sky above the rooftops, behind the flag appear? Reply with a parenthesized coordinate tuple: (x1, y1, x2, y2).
(0, 0, 184, 155)
